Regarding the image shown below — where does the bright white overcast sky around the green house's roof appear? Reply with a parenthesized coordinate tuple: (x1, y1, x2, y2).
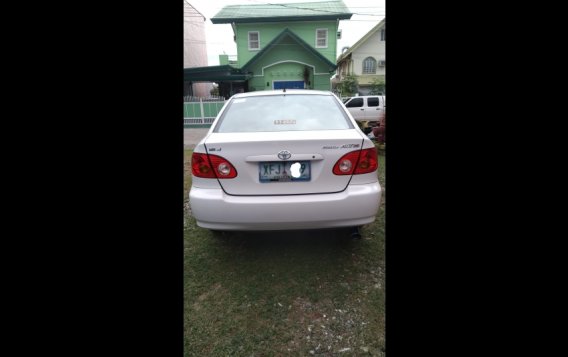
(188, 0, 385, 66)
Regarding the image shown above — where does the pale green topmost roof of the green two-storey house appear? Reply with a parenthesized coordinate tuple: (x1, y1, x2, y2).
(211, 0, 353, 24)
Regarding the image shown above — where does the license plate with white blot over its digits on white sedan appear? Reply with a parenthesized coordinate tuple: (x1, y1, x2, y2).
(258, 161, 311, 182)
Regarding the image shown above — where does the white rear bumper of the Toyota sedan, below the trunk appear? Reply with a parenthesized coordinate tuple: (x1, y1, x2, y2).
(189, 182, 381, 231)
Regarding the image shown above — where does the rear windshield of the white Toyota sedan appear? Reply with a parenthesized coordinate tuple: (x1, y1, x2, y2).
(213, 94, 353, 133)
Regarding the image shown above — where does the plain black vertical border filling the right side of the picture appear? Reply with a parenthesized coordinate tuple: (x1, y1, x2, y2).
(386, 1, 549, 356)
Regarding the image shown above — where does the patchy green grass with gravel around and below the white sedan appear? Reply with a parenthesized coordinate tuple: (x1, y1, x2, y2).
(184, 150, 385, 356)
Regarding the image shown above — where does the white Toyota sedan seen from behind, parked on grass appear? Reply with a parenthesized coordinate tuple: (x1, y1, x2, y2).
(189, 90, 381, 231)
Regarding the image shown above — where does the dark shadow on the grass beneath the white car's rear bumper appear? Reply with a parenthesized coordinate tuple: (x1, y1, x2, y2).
(191, 229, 382, 300)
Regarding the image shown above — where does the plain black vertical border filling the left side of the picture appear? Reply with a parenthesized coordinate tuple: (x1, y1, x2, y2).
(16, 1, 183, 356)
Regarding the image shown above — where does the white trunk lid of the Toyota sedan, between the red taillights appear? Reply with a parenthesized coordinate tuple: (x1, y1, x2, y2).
(205, 129, 364, 196)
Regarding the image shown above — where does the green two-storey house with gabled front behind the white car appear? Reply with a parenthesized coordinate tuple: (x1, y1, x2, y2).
(211, 0, 352, 91)
